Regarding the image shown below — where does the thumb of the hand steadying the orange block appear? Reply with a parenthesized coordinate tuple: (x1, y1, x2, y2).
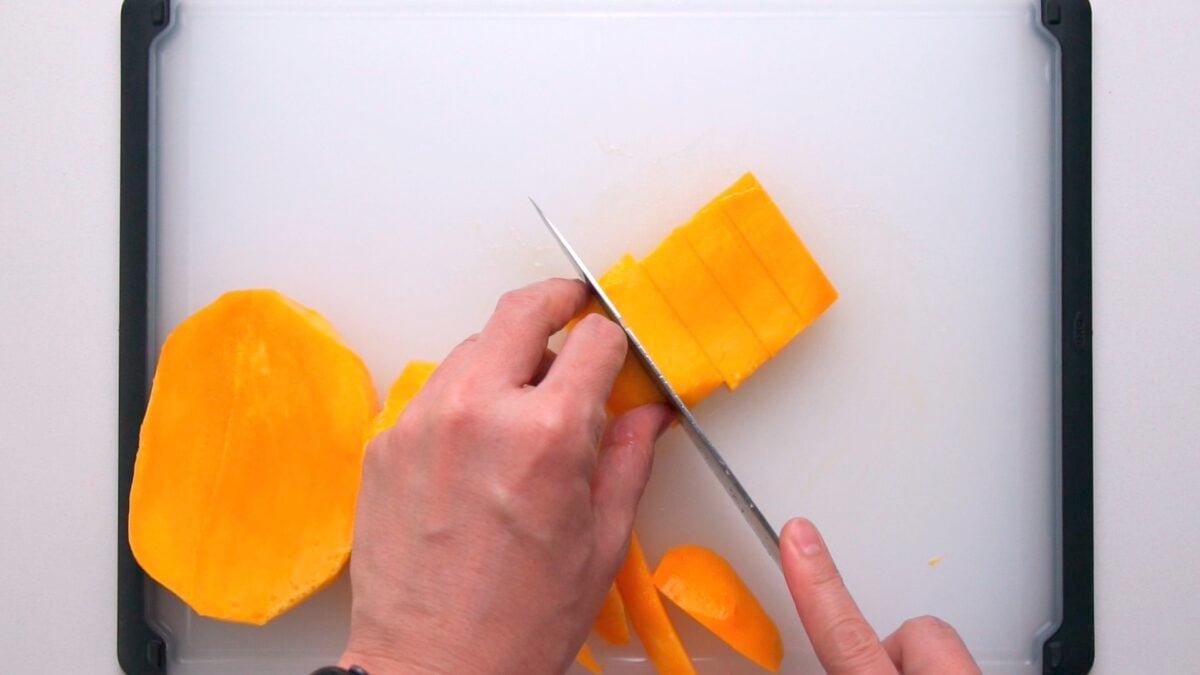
(592, 404, 672, 573)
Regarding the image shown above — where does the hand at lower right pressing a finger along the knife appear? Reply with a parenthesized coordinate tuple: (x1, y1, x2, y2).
(780, 518, 979, 675)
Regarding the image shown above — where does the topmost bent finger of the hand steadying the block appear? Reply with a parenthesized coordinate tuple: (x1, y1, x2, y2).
(473, 279, 588, 386)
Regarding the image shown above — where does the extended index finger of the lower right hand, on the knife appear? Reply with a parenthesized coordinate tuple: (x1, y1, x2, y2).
(780, 518, 896, 675)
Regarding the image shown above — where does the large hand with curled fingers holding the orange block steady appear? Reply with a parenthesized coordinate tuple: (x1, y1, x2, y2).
(341, 279, 670, 675)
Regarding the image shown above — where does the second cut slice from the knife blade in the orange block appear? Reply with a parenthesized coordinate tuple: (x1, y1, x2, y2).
(641, 229, 770, 389)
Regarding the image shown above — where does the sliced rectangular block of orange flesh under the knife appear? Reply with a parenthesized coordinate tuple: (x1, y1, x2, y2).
(589, 173, 838, 414)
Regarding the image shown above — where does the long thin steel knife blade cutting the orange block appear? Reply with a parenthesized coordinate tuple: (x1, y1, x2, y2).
(529, 197, 779, 566)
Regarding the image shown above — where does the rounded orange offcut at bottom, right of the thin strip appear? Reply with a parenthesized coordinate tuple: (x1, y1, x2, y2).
(654, 545, 784, 673)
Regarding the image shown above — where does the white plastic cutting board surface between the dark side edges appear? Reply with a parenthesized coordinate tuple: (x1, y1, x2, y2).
(150, 0, 1060, 674)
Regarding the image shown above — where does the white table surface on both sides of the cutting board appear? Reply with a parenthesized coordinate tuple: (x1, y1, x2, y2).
(0, 0, 1200, 674)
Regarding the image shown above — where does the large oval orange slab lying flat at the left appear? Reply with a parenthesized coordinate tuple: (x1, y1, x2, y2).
(128, 289, 377, 623)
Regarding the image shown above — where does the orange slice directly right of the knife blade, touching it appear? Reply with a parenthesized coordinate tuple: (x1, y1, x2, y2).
(600, 255, 721, 410)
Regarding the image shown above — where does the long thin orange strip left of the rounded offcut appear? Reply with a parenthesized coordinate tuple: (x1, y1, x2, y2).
(617, 532, 696, 675)
